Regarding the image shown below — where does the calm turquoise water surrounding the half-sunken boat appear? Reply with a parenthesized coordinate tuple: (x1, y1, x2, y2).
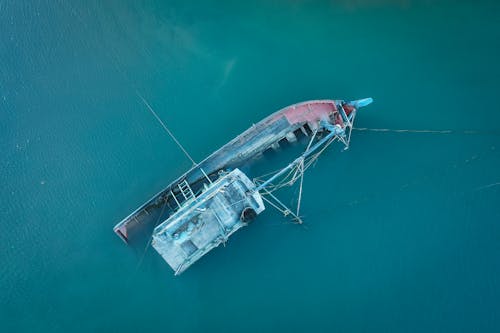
(0, 0, 500, 332)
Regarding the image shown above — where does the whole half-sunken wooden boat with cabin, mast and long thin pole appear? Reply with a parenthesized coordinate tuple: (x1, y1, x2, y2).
(113, 98, 373, 275)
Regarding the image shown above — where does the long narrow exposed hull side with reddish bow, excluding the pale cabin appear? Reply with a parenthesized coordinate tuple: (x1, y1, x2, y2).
(113, 100, 348, 242)
